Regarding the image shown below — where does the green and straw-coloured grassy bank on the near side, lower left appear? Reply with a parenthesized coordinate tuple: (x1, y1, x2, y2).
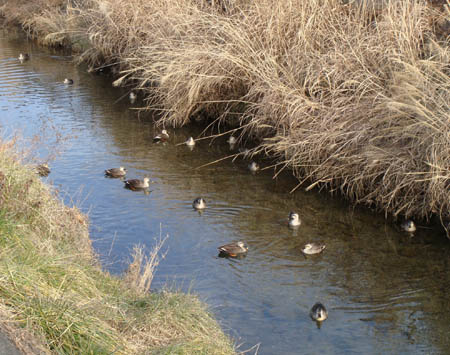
(0, 138, 234, 354)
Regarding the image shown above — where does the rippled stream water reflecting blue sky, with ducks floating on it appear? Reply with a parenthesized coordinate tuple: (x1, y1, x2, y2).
(0, 29, 450, 354)
